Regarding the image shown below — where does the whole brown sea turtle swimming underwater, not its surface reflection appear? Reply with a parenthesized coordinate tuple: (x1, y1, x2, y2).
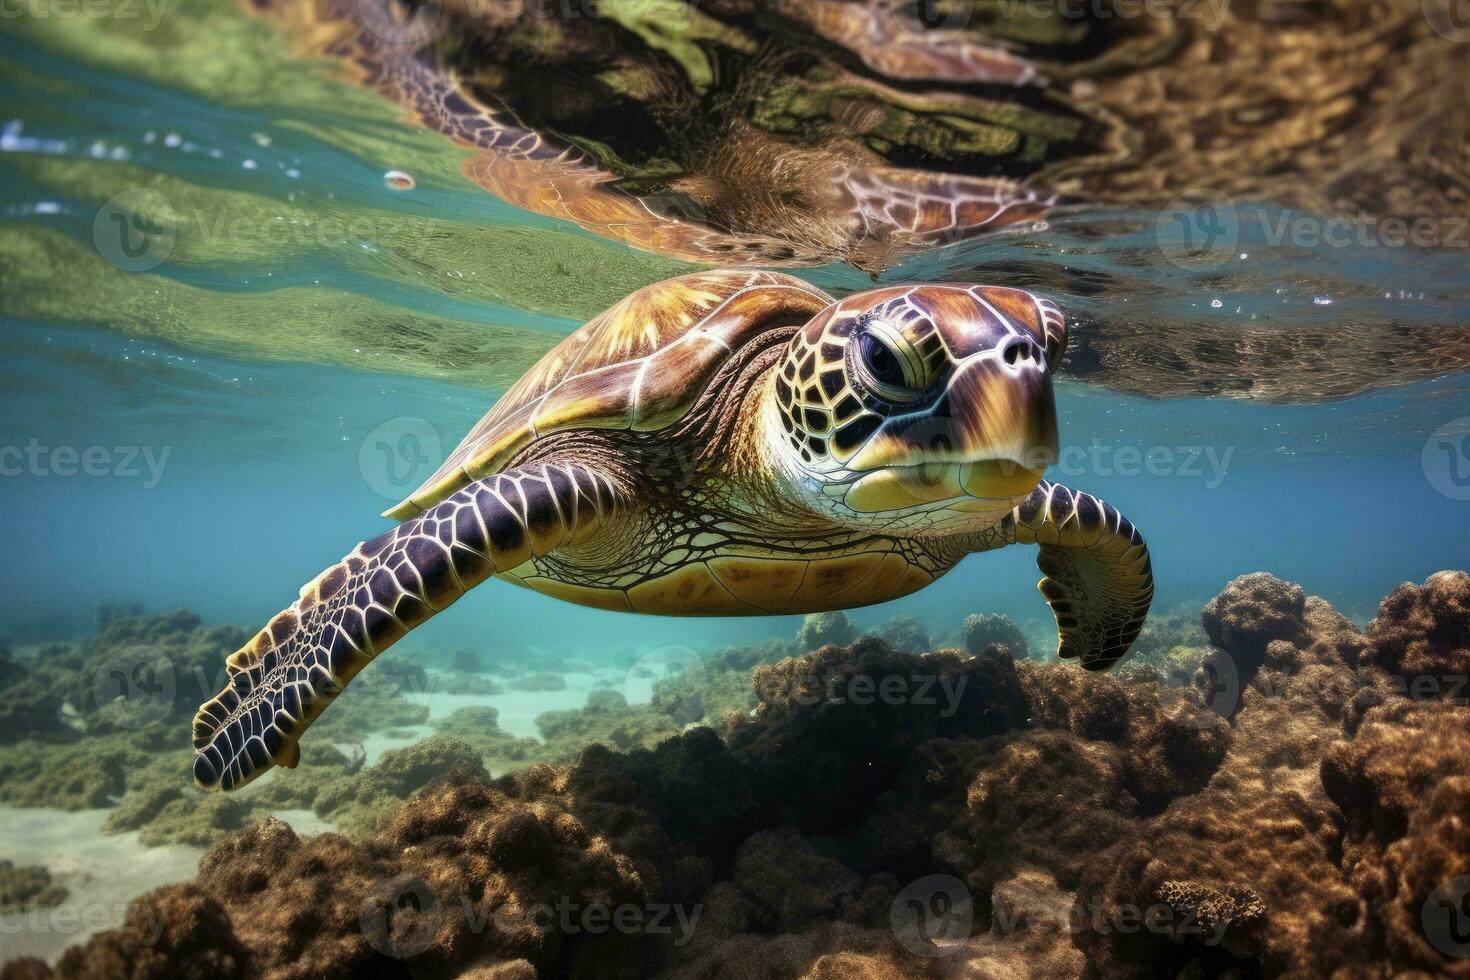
(194, 269, 1152, 789)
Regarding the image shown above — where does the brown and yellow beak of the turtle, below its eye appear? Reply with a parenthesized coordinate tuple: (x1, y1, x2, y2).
(848, 346, 1057, 510)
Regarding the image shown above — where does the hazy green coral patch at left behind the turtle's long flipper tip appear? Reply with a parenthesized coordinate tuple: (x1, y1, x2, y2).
(0, 610, 451, 846)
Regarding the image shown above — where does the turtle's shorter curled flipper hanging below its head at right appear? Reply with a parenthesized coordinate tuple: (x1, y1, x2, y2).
(1003, 480, 1154, 670)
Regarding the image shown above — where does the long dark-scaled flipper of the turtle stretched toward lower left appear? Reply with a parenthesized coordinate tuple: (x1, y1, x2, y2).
(194, 463, 617, 789)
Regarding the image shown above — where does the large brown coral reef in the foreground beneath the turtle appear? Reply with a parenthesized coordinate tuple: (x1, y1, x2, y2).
(4, 573, 1470, 980)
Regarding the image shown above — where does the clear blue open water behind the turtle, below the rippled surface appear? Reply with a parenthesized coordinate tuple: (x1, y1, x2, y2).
(11, 314, 1470, 657)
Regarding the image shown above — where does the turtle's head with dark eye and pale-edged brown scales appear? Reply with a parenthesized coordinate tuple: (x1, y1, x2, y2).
(767, 285, 1066, 533)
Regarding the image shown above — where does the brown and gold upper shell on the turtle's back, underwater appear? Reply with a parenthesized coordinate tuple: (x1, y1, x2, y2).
(384, 269, 832, 520)
